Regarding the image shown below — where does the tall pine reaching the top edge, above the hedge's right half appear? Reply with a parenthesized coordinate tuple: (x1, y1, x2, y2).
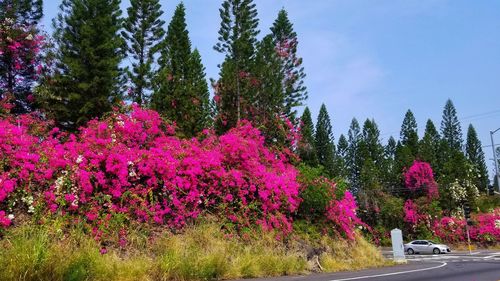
(214, 0, 259, 132)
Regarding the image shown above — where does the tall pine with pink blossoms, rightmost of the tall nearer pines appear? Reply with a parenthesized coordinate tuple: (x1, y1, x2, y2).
(271, 9, 307, 119)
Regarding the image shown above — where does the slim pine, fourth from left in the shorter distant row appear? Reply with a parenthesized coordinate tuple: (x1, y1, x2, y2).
(346, 118, 362, 193)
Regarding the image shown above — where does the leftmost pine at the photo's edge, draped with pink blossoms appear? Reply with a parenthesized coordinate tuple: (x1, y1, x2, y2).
(0, 0, 44, 114)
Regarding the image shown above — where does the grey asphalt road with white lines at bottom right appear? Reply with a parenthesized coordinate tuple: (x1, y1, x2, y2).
(244, 252, 500, 281)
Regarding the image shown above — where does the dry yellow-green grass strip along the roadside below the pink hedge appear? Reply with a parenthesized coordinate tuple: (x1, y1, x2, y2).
(0, 223, 387, 281)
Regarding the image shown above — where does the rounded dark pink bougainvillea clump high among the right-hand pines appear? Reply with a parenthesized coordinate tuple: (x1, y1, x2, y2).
(404, 160, 439, 198)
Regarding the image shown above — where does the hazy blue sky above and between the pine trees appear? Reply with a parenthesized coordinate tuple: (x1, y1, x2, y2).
(44, 0, 500, 177)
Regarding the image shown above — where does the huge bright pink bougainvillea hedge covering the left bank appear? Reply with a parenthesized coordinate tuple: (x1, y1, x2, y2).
(0, 107, 299, 234)
